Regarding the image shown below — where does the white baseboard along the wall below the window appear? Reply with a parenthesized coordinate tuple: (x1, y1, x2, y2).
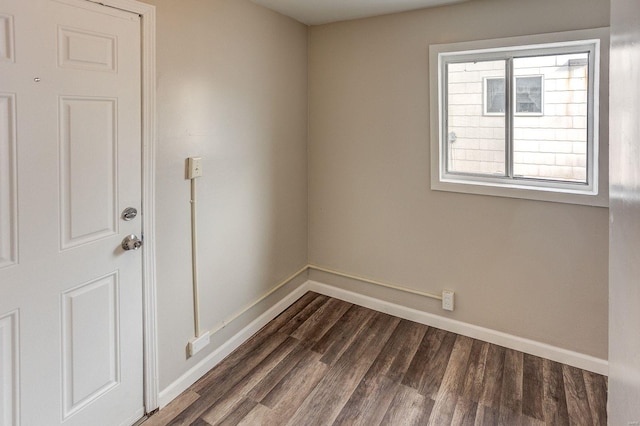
(308, 280, 609, 376)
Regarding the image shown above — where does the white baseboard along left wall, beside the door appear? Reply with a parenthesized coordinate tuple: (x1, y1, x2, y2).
(158, 282, 308, 408)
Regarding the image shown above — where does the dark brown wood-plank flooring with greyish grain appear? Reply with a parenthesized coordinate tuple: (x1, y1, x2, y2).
(143, 292, 607, 426)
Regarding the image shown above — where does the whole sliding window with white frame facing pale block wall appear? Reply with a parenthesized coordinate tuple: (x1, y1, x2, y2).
(430, 30, 607, 205)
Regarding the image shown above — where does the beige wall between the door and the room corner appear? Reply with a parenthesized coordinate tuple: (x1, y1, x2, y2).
(148, 0, 307, 390)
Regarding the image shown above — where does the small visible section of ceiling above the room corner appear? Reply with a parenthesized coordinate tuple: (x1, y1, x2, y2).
(252, 0, 466, 25)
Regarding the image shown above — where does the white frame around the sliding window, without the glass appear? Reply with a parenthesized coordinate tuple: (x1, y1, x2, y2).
(429, 28, 609, 207)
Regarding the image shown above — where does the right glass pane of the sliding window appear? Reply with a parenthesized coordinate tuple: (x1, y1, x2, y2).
(513, 53, 589, 182)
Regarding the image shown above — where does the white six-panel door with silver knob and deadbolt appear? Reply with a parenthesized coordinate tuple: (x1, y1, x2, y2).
(0, 0, 144, 426)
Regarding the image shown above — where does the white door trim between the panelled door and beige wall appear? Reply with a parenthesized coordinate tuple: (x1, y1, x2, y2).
(86, 0, 159, 413)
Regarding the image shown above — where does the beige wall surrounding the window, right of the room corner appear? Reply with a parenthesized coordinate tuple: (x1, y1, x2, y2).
(309, 0, 609, 358)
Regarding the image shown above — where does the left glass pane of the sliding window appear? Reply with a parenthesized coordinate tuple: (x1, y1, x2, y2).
(446, 60, 506, 176)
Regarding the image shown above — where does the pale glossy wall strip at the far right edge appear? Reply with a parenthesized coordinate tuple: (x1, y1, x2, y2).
(609, 0, 640, 425)
